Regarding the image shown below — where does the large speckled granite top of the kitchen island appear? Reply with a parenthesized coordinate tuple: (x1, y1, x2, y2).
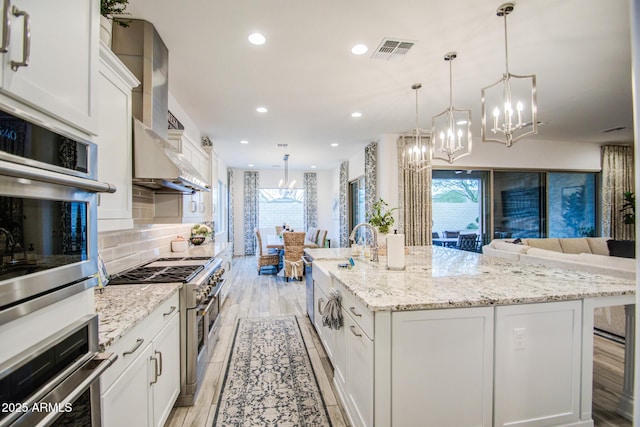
(307, 246, 636, 311)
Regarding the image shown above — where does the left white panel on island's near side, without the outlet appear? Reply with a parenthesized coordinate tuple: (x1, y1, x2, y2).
(391, 307, 493, 426)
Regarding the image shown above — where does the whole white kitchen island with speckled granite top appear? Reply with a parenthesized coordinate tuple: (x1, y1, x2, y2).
(306, 247, 635, 426)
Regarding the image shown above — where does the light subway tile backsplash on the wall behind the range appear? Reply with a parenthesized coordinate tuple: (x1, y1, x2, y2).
(98, 224, 194, 274)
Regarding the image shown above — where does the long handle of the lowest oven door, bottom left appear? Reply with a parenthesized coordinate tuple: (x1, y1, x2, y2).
(3, 353, 118, 425)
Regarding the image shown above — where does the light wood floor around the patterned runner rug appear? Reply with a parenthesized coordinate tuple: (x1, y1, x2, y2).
(166, 257, 632, 427)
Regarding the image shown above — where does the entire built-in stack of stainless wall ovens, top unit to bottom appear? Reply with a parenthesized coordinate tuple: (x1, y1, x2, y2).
(0, 111, 115, 426)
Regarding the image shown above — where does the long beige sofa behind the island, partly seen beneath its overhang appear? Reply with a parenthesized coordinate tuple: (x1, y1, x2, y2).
(482, 237, 636, 337)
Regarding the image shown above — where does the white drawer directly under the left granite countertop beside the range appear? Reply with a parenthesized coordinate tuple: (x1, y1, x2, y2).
(100, 292, 180, 392)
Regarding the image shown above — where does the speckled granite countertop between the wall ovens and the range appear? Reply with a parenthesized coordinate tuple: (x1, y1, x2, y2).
(95, 283, 182, 351)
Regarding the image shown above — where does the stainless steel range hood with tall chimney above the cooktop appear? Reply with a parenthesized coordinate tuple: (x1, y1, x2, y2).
(111, 19, 209, 193)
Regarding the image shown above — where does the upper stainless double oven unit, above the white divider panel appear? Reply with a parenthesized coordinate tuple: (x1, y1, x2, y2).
(0, 111, 115, 324)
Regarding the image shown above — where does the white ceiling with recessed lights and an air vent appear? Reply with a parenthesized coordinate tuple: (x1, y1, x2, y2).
(122, 0, 633, 169)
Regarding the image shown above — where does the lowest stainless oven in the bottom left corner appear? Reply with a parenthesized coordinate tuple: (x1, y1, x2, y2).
(0, 315, 117, 427)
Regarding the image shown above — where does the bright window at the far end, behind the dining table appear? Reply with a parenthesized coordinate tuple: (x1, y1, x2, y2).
(258, 188, 304, 232)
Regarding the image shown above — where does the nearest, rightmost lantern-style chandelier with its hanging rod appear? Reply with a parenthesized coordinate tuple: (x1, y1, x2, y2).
(480, 3, 538, 147)
